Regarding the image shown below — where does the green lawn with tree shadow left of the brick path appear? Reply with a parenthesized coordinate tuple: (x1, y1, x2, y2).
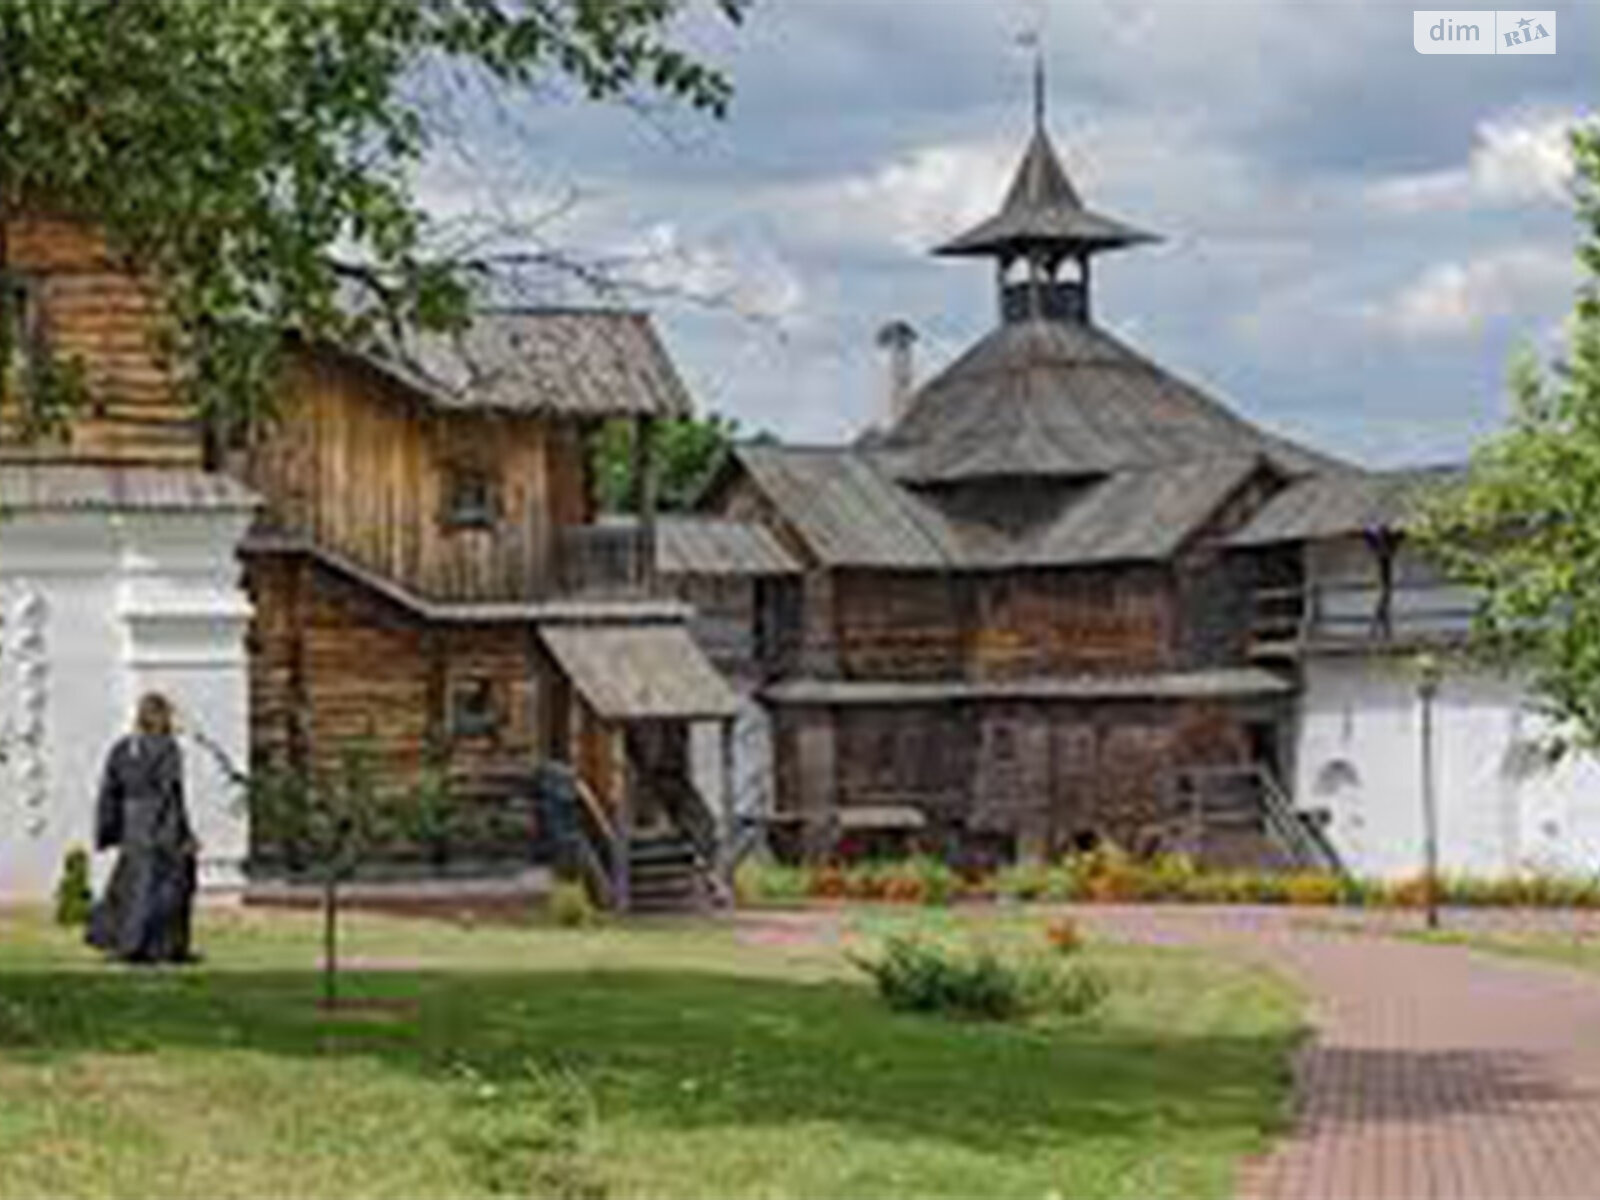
(0, 910, 1299, 1200)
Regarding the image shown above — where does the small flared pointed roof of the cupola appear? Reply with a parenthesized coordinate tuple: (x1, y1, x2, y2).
(934, 126, 1158, 256)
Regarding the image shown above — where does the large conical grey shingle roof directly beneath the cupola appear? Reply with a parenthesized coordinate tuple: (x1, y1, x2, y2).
(874, 320, 1331, 483)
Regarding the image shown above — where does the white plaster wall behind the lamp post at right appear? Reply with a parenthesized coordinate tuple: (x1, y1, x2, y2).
(1294, 654, 1600, 878)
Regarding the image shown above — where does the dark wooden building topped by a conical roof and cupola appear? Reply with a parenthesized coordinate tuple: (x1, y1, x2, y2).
(702, 105, 1342, 866)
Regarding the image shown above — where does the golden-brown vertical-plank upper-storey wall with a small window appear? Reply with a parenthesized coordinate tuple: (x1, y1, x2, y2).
(245, 350, 590, 600)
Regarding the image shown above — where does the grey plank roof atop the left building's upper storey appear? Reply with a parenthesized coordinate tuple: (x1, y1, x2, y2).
(334, 309, 691, 418)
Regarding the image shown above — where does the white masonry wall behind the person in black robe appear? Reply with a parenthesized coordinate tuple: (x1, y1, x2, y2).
(0, 510, 250, 899)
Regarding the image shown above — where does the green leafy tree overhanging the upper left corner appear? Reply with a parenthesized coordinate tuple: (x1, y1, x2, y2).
(0, 0, 744, 441)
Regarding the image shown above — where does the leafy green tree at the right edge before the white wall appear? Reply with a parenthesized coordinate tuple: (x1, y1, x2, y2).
(1416, 123, 1600, 750)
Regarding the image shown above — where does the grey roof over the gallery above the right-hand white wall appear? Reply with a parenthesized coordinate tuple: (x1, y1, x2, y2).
(1227, 466, 1462, 547)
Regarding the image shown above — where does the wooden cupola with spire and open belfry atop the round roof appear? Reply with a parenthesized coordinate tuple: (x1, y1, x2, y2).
(934, 72, 1158, 322)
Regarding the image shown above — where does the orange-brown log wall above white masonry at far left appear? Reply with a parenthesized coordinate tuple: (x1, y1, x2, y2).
(0, 218, 202, 466)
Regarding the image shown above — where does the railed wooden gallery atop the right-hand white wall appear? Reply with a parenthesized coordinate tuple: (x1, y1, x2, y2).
(1250, 582, 1477, 658)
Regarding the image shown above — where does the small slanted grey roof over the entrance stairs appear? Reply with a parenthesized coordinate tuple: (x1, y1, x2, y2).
(539, 624, 738, 722)
